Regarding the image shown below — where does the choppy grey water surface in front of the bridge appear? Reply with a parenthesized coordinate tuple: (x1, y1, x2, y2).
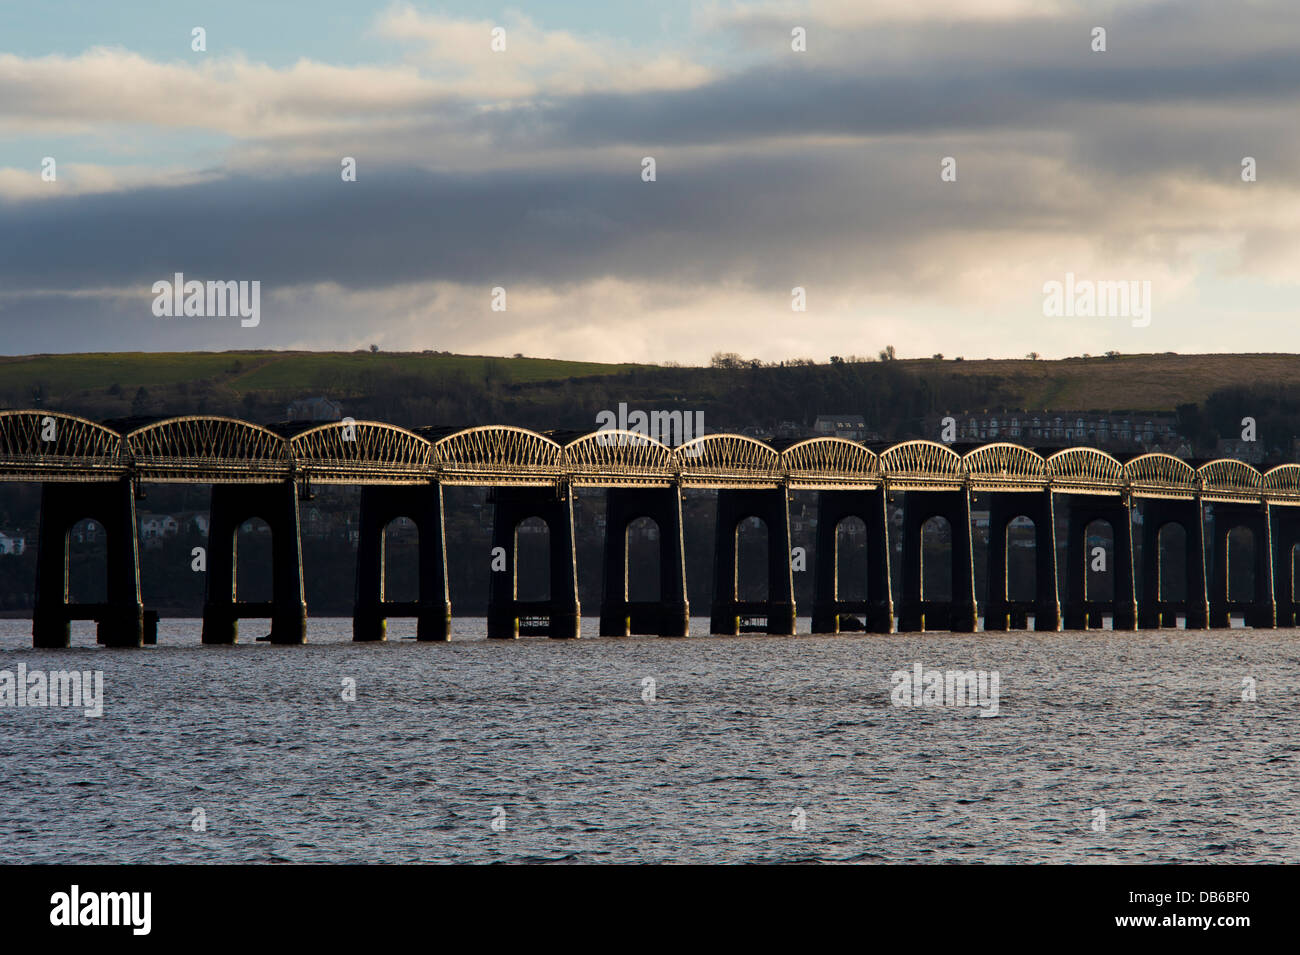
(0, 620, 1300, 863)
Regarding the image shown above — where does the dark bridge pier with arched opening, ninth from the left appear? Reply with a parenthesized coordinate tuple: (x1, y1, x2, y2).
(984, 490, 1061, 630)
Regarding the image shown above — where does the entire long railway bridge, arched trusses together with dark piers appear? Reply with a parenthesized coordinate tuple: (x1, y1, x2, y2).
(0, 409, 1300, 647)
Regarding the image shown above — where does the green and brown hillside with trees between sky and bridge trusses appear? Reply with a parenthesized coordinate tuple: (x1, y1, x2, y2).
(0, 352, 1300, 447)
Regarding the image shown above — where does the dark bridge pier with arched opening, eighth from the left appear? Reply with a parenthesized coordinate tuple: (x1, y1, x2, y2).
(898, 490, 979, 633)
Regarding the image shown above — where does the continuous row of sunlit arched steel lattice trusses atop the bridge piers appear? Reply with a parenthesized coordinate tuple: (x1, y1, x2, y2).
(0, 409, 1300, 505)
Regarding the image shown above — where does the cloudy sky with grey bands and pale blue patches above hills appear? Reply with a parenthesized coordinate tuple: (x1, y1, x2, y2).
(0, 0, 1300, 364)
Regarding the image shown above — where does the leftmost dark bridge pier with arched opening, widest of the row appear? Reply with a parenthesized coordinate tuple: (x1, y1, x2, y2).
(31, 478, 146, 647)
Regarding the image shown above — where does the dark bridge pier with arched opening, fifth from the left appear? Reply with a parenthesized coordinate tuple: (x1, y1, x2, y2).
(601, 485, 690, 637)
